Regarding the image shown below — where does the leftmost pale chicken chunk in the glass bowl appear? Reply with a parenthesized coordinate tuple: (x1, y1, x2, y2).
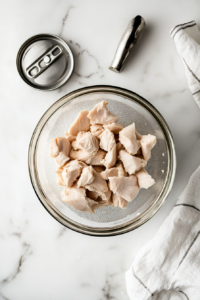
(55, 137, 71, 167)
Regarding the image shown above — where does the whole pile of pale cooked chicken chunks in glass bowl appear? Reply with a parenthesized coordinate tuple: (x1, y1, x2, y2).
(50, 101, 156, 213)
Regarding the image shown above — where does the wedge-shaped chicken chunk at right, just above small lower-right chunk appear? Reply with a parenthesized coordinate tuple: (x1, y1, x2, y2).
(119, 150, 147, 175)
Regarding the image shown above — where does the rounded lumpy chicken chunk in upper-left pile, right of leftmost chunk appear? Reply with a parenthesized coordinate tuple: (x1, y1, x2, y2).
(72, 131, 99, 154)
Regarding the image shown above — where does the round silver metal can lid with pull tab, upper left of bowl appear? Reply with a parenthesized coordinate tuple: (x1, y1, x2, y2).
(16, 34, 74, 91)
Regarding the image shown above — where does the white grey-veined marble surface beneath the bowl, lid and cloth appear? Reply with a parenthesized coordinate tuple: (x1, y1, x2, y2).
(0, 0, 200, 300)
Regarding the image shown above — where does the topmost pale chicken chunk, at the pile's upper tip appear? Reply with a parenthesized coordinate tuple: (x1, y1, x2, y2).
(88, 101, 119, 124)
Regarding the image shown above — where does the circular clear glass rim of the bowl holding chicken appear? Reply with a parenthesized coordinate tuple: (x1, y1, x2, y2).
(28, 85, 176, 236)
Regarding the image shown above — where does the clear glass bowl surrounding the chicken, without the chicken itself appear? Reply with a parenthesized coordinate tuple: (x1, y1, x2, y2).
(28, 86, 176, 236)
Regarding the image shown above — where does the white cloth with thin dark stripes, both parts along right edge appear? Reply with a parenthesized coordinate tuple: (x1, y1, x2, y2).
(126, 21, 200, 300)
